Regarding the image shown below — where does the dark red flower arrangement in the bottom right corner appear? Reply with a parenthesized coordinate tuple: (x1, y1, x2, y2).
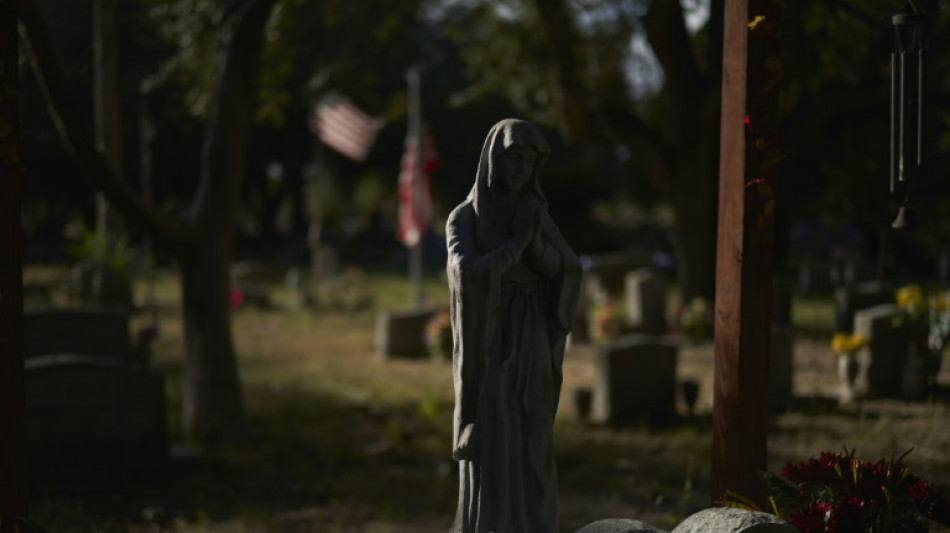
(724, 449, 950, 533)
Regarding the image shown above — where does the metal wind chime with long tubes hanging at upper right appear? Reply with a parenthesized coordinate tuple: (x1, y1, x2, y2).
(891, 0, 930, 228)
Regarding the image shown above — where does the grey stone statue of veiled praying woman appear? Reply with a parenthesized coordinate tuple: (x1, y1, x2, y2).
(446, 119, 581, 533)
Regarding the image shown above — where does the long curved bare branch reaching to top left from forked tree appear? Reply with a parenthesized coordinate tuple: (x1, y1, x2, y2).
(19, 2, 186, 251)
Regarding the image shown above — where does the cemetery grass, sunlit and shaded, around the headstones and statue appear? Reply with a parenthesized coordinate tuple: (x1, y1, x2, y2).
(18, 268, 950, 533)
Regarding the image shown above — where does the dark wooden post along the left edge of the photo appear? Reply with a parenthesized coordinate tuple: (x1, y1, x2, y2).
(0, 0, 27, 533)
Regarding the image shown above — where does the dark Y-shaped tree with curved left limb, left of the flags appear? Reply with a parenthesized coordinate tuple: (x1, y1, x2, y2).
(20, 0, 274, 445)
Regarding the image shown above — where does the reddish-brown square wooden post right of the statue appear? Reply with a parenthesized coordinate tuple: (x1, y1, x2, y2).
(711, 0, 781, 504)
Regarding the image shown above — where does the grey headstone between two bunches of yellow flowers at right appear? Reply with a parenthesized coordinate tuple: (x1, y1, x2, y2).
(854, 304, 914, 398)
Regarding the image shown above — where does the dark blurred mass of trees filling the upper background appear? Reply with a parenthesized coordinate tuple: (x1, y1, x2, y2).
(21, 0, 950, 440)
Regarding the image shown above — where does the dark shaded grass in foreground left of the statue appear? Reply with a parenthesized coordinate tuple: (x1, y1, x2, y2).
(31, 388, 457, 531)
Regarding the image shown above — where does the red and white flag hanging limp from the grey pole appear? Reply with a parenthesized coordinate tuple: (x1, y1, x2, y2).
(397, 126, 439, 248)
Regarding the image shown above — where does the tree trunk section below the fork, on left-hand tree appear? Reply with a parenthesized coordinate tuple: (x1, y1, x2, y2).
(179, 236, 244, 446)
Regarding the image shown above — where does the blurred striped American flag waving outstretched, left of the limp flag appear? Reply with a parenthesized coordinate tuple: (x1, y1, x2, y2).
(310, 96, 386, 161)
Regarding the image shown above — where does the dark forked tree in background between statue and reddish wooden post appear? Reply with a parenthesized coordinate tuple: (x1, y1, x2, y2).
(534, 0, 723, 301)
